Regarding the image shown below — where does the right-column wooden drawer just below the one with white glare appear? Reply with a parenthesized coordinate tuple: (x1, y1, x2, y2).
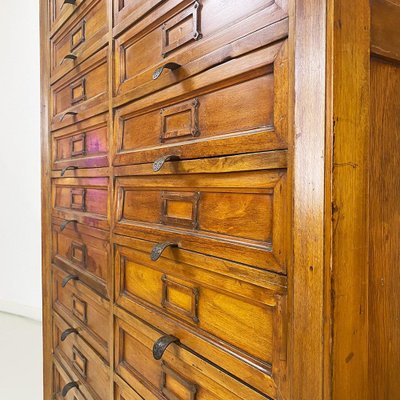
(114, 43, 288, 165)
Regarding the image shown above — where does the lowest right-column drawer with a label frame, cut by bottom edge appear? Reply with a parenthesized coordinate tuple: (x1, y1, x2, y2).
(115, 309, 266, 400)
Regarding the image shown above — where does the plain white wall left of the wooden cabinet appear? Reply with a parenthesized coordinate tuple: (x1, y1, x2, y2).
(0, 0, 41, 319)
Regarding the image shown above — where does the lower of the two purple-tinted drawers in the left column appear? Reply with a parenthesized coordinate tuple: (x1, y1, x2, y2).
(52, 177, 109, 229)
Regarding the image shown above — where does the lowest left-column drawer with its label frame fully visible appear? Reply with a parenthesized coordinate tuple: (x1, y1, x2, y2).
(53, 314, 110, 400)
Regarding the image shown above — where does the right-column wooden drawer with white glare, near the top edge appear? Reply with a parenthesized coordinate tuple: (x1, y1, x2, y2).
(114, 0, 288, 103)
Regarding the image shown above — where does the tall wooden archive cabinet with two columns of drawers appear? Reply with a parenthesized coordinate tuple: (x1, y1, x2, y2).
(40, 0, 400, 400)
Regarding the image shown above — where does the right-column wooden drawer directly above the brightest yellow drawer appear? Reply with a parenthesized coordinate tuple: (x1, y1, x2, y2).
(114, 151, 288, 272)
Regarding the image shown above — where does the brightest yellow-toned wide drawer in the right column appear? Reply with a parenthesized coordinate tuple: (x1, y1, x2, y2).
(115, 237, 287, 395)
